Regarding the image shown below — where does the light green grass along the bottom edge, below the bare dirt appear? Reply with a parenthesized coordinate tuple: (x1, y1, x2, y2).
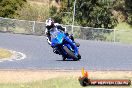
(0, 77, 132, 88)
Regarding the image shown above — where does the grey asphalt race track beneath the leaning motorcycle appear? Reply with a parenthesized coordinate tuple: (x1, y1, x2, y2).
(0, 33, 132, 70)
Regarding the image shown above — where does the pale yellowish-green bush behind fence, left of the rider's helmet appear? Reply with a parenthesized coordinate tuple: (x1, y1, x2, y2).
(14, 3, 49, 21)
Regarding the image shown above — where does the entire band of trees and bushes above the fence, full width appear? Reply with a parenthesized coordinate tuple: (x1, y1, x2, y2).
(0, 0, 132, 28)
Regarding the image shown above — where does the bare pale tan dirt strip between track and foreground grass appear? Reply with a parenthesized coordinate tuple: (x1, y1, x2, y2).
(0, 70, 132, 83)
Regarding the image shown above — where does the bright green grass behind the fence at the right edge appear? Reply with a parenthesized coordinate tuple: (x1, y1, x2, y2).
(105, 22, 132, 44)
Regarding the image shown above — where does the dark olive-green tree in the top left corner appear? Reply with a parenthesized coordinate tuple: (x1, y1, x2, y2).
(0, 0, 26, 18)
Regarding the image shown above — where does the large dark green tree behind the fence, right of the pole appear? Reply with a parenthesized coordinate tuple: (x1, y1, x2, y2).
(76, 0, 116, 28)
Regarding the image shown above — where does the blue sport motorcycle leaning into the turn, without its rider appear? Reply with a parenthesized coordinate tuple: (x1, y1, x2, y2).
(50, 28, 81, 61)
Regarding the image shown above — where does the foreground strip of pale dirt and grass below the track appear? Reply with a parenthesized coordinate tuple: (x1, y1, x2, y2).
(0, 70, 132, 88)
